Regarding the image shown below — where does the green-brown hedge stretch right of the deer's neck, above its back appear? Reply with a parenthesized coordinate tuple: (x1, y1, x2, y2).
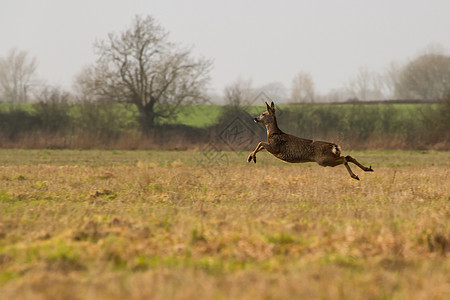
(279, 104, 449, 149)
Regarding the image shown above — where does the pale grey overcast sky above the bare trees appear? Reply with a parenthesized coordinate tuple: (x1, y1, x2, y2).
(0, 0, 450, 99)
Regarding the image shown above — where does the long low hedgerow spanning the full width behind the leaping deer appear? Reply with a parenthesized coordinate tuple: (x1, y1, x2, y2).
(0, 102, 450, 150)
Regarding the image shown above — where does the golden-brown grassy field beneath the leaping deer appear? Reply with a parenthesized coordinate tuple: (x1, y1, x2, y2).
(0, 150, 450, 299)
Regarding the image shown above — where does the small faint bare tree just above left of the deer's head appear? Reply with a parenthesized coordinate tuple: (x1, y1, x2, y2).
(224, 77, 254, 107)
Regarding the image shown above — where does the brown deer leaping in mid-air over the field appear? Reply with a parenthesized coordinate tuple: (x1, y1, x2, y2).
(248, 102, 373, 180)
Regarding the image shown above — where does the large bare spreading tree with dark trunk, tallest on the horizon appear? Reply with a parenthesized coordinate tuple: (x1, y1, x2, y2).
(78, 16, 212, 130)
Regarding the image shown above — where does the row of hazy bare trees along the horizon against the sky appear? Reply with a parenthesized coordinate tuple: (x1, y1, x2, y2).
(0, 16, 450, 133)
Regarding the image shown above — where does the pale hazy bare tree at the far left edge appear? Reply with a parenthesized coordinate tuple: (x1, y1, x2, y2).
(0, 48, 37, 103)
